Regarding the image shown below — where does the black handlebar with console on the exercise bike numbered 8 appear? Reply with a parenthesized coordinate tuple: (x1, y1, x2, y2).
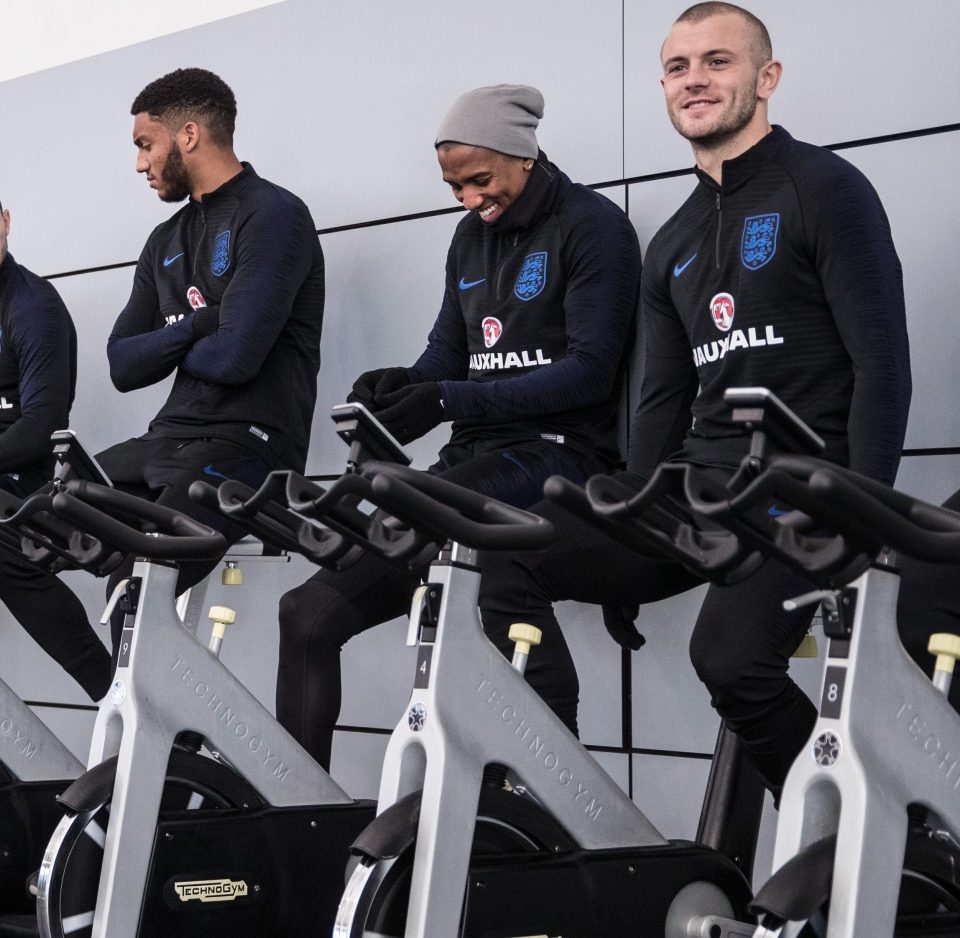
(546, 388, 960, 586)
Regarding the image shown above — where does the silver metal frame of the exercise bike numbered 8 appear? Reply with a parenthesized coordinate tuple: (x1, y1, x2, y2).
(768, 565, 960, 938)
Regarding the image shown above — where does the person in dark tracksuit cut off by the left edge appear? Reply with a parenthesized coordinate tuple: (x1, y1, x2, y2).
(0, 205, 110, 700)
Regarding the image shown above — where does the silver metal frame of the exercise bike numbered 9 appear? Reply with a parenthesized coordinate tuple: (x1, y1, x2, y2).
(46, 560, 353, 938)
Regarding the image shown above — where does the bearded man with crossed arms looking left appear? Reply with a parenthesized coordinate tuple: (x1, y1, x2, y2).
(9, 68, 324, 649)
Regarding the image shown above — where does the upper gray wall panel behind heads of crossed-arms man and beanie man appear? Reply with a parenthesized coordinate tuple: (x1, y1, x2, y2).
(0, 0, 622, 273)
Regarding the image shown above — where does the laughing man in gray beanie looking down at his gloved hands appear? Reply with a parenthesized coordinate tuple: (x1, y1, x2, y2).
(277, 85, 640, 766)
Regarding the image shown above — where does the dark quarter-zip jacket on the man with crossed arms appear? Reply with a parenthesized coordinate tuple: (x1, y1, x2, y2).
(107, 163, 324, 471)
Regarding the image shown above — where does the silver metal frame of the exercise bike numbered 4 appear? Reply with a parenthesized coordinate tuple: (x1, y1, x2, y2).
(377, 544, 667, 938)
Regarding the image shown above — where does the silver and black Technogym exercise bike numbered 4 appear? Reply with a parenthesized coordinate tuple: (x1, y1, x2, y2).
(204, 407, 772, 938)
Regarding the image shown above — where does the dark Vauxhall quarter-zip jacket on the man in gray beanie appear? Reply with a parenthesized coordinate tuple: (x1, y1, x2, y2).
(412, 152, 640, 462)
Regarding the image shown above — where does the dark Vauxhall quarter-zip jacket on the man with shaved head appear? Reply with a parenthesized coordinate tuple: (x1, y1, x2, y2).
(630, 127, 911, 483)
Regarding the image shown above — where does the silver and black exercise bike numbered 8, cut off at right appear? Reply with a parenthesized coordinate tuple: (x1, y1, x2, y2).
(548, 388, 960, 938)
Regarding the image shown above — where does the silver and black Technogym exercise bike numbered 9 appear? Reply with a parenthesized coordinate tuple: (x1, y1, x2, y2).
(0, 436, 374, 938)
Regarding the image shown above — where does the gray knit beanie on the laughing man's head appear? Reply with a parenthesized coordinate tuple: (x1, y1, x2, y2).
(434, 85, 543, 159)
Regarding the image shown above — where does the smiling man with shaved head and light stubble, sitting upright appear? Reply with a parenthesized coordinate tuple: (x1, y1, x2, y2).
(480, 3, 911, 794)
